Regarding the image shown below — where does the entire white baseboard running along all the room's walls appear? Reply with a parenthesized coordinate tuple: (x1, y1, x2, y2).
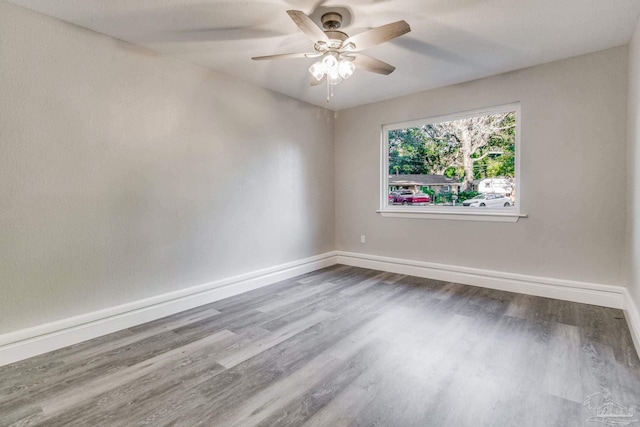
(0, 251, 640, 366)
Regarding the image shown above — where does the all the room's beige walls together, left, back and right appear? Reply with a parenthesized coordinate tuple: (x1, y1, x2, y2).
(0, 1, 640, 342)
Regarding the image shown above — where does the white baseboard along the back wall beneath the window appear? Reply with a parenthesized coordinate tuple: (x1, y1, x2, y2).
(336, 251, 626, 309)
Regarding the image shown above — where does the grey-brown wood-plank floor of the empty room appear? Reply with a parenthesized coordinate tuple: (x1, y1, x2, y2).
(0, 266, 640, 427)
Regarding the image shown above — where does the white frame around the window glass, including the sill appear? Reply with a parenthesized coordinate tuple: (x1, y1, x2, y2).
(377, 102, 526, 222)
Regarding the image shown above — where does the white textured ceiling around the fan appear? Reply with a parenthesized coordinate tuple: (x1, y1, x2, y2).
(11, 0, 640, 110)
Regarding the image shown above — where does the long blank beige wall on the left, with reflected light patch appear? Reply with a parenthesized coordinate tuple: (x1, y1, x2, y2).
(0, 1, 335, 334)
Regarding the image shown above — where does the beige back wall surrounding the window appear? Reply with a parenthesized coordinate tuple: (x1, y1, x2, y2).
(335, 46, 627, 285)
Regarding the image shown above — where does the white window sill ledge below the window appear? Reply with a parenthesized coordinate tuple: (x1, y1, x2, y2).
(376, 208, 527, 222)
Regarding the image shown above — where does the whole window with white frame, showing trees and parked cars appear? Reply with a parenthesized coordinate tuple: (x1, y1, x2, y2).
(380, 104, 524, 221)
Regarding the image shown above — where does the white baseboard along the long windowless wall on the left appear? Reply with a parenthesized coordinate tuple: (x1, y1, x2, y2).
(0, 252, 336, 366)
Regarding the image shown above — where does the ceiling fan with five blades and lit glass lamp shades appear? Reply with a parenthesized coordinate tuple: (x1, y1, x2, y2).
(251, 10, 411, 102)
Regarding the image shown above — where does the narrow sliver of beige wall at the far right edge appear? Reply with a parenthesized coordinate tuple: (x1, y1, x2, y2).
(627, 20, 640, 310)
